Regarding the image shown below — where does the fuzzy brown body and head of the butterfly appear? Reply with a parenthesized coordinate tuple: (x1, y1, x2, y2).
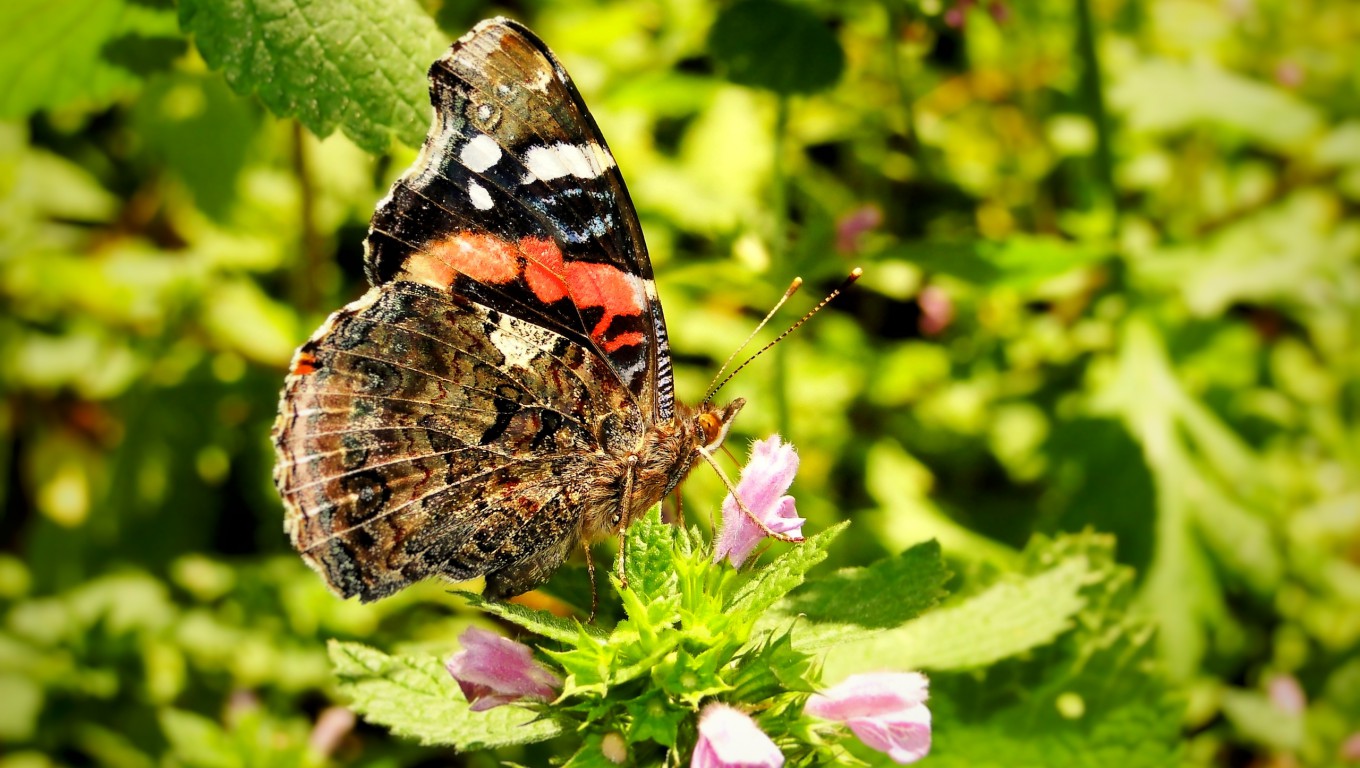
(581, 398, 745, 541)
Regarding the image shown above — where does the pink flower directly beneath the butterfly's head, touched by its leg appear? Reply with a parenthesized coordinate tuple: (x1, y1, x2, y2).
(713, 435, 802, 568)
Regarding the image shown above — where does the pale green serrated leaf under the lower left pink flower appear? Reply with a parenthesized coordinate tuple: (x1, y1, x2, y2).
(329, 640, 562, 750)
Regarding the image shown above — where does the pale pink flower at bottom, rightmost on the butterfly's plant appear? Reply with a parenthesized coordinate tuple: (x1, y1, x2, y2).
(802, 671, 930, 765)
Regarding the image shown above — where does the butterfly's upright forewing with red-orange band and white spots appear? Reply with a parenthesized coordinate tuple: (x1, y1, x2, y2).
(366, 19, 673, 419)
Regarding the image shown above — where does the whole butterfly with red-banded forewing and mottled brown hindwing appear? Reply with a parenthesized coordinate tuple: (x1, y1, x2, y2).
(273, 18, 744, 602)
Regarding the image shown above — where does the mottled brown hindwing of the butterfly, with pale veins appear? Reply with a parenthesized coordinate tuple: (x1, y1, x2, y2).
(275, 281, 643, 601)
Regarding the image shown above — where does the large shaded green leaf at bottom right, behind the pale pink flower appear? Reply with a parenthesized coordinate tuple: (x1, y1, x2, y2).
(924, 533, 1183, 768)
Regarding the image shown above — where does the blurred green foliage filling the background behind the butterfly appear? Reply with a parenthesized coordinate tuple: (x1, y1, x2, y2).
(0, 0, 1360, 768)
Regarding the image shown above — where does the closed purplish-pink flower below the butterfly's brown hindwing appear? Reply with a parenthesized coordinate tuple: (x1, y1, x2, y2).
(445, 627, 562, 712)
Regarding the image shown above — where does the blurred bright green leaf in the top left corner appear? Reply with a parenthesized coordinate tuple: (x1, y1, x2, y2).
(0, 0, 185, 120)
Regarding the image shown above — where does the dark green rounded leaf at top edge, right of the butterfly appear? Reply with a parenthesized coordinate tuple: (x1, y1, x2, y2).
(709, 0, 846, 95)
